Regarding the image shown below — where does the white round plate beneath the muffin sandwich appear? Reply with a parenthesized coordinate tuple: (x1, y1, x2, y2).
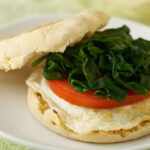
(0, 15, 150, 150)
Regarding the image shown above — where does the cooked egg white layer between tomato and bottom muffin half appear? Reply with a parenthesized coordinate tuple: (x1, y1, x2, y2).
(26, 70, 150, 133)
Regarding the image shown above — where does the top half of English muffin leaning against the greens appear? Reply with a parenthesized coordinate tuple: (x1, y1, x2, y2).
(0, 10, 110, 71)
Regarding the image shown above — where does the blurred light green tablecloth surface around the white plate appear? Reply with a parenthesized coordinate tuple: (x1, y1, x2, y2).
(0, 0, 150, 150)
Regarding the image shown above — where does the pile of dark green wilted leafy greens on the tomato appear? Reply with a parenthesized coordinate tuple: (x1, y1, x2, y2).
(33, 25, 150, 103)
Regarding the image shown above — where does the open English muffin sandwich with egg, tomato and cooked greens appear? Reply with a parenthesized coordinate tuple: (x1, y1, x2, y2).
(0, 10, 150, 143)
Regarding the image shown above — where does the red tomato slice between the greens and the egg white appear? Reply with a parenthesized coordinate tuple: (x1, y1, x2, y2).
(47, 80, 150, 108)
